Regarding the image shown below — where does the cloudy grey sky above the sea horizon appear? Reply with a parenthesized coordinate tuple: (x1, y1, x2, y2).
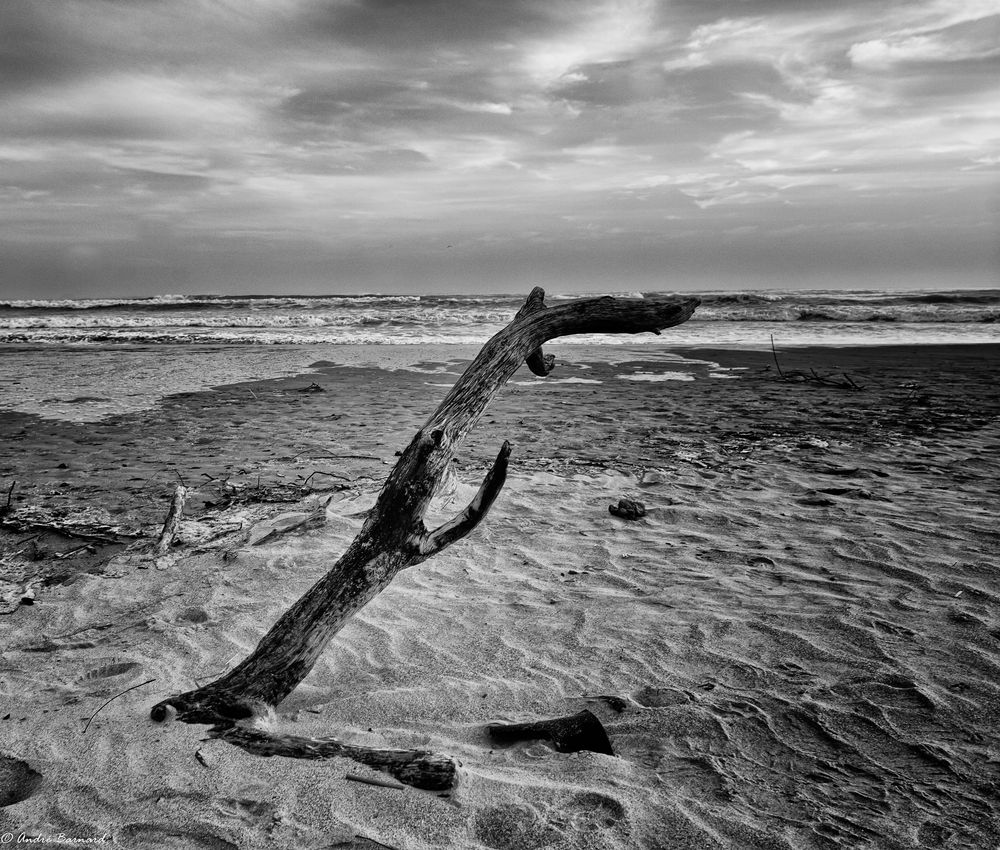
(0, 0, 1000, 298)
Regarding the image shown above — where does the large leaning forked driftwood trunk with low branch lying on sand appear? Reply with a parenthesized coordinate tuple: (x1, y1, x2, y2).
(150, 287, 699, 788)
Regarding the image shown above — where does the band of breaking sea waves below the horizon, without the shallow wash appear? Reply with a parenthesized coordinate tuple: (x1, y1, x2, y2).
(0, 289, 1000, 347)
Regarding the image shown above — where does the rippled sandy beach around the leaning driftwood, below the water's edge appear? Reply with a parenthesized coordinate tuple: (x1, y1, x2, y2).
(0, 345, 1000, 850)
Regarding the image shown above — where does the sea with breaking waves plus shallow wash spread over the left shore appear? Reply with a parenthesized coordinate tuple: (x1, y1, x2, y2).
(0, 290, 1000, 422)
